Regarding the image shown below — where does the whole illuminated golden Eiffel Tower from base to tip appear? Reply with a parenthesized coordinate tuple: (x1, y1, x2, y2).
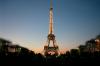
(44, 0, 59, 56)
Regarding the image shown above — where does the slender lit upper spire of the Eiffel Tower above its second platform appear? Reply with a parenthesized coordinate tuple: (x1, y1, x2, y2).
(49, 0, 53, 34)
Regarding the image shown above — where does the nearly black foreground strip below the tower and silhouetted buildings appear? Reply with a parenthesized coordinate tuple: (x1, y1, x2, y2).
(0, 52, 100, 65)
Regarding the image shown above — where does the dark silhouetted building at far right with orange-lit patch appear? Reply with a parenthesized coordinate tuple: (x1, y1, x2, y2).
(78, 39, 100, 53)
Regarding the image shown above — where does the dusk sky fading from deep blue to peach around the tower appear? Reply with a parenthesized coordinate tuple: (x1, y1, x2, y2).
(0, 0, 100, 51)
